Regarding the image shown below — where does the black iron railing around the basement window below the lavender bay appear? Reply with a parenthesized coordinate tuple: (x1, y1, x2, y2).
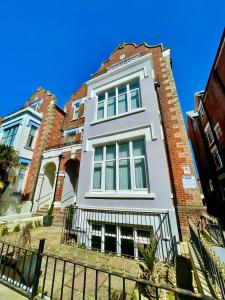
(61, 206, 176, 261)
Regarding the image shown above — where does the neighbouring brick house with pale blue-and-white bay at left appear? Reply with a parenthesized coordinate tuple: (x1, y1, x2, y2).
(0, 88, 65, 215)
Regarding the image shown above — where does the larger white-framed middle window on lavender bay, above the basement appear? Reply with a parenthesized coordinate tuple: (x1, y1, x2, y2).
(93, 139, 147, 191)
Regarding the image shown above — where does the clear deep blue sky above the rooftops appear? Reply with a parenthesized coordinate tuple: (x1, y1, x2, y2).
(0, 0, 225, 116)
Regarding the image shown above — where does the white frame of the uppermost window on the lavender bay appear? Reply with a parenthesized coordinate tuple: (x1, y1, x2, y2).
(96, 77, 142, 121)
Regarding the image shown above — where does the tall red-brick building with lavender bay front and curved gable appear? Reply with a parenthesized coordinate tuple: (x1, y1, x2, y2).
(31, 43, 203, 257)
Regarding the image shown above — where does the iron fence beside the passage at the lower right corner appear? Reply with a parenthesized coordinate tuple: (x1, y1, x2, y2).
(189, 221, 225, 299)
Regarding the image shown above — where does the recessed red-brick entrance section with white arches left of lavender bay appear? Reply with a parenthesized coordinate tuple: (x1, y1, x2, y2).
(34, 85, 87, 211)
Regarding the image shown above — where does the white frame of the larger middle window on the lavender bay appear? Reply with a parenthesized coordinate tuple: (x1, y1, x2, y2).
(91, 137, 149, 193)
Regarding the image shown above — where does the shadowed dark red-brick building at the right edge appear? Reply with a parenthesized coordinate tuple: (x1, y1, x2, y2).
(187, 31, 225, 226)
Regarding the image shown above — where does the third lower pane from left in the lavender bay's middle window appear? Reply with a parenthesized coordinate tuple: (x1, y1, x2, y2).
(119, 159, 131, 190)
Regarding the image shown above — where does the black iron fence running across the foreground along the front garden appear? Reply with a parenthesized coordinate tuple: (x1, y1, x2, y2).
(0, 240, 216, 300)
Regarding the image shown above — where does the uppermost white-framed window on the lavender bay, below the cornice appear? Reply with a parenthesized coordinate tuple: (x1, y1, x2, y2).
(97, 80, 141, 120)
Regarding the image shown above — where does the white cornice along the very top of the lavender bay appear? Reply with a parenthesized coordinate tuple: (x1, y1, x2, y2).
(86, 53, 152, 86)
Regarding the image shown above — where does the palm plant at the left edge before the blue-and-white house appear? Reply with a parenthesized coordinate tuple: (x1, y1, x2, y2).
(0, 144, 19, 194)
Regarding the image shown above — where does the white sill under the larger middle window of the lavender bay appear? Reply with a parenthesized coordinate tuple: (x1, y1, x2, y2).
(85, 191, 155, 199)
